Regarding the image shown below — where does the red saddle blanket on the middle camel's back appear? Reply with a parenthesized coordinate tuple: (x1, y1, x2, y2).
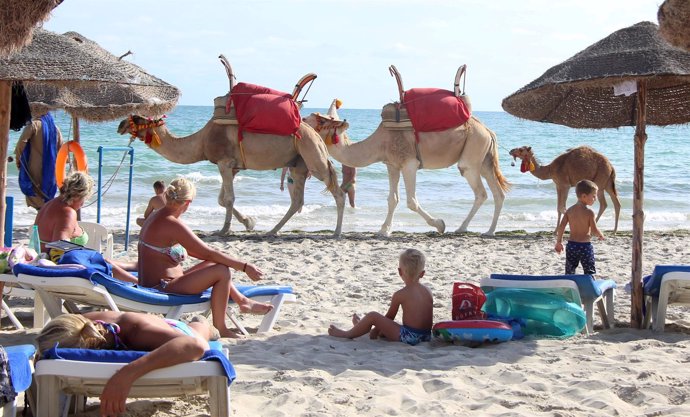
(404, 88, 470, 132)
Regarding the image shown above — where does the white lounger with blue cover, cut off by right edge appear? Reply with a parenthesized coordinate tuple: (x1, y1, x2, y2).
(643, 265, 690, 332)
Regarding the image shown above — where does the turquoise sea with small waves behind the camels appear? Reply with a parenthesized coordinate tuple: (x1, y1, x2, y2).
(8, 106, 690, 236)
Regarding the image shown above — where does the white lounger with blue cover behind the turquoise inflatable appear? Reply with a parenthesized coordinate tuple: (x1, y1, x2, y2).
(481, 274, 616, 334)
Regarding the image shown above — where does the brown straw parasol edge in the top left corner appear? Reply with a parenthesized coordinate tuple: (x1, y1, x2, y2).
(0, 0, 62, 56)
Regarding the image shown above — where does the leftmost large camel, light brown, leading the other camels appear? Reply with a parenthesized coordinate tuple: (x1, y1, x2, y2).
(117, 116, 345, 236)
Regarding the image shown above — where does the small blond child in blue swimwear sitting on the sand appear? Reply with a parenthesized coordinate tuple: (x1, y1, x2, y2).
(328, 249, 434, 345)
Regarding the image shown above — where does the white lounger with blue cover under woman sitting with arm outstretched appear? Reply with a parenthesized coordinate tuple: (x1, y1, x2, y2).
(14, 264, 296, 334)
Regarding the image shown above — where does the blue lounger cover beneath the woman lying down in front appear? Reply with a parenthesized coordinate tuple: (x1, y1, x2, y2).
(44, 341, 237, 385)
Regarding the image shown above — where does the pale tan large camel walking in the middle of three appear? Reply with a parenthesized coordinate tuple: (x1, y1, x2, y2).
(303, 100, 510, 236)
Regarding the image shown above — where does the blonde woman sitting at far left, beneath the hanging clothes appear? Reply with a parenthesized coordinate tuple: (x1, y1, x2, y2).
(34, 171, 137, 282)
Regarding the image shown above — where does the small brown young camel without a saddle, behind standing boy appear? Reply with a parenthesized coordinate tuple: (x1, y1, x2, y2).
(510, 146, 621, 234)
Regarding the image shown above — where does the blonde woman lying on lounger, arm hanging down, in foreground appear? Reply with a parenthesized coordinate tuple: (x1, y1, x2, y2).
(36, 311, 217, 416)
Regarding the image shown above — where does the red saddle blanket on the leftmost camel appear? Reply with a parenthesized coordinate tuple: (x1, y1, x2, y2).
(230, 83, 301, 141)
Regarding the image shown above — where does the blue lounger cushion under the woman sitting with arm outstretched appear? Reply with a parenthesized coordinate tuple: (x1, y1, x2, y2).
(13, 264, 292, 306)
